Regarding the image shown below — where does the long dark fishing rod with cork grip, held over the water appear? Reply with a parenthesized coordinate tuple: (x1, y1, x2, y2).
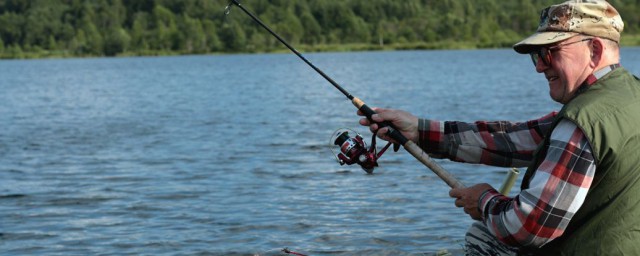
(225, 0, 465, 188)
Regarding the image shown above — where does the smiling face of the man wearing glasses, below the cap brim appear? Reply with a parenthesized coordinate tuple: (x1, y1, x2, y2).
(532, 36, 591, 104)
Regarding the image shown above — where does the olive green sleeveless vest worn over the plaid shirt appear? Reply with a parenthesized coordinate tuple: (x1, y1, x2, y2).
(522, 67, 640, 255)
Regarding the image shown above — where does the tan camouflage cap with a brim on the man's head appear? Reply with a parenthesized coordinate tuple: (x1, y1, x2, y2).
(513, 0, 624, 53)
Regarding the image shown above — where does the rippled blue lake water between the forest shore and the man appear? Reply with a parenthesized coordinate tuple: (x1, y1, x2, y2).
(0, 48, 640, 255)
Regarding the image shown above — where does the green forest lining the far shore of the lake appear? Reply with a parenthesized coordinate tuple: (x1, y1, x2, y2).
(0, 0, 640, 59)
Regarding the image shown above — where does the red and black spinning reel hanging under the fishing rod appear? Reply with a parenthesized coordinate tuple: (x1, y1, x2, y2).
(330, 128, 392, 174)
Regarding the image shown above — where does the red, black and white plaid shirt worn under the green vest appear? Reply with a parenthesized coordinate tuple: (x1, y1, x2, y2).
(419, 112, 596, 247)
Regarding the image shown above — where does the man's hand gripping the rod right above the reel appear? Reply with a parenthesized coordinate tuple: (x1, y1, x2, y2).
(358, 108, 418, 144)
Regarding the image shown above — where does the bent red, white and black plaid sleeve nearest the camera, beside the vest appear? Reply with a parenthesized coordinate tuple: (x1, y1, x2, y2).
(479, 120, 596, 247)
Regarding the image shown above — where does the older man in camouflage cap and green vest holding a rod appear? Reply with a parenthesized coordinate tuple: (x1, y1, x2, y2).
(360, 0, 640, 255)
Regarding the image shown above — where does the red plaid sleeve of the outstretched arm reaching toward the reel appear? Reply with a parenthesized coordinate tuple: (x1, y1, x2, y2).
(418, 112, 556, 167)
